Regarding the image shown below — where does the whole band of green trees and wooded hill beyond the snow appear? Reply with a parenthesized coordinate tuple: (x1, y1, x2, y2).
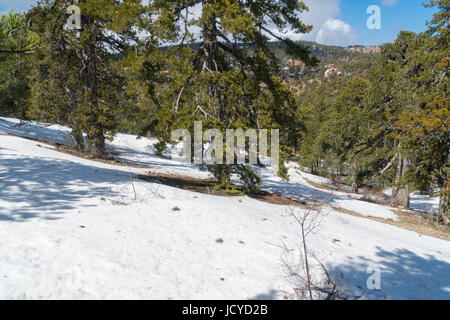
(0, 0, 450, 220)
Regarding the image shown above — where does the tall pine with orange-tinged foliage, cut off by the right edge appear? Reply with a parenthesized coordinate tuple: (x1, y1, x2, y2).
(397, 0, 450, 223)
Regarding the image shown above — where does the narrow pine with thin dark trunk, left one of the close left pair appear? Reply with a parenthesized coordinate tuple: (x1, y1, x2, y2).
(28, 1, 84, 150)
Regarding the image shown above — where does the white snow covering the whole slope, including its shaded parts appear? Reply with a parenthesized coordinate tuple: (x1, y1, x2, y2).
(0, 118, 450, 299)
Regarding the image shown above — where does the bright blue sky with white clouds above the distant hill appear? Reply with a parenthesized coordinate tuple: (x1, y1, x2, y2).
(0, 0, 435, 46)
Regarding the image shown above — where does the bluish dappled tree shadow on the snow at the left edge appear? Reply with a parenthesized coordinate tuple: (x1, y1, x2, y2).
(0, 147, 139, 221)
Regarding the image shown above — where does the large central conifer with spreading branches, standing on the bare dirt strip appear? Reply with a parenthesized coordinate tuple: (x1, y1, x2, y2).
(143, 0, 316, 185)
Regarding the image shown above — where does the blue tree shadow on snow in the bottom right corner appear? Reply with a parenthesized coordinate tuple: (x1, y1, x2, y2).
(328, 247, 450, 300)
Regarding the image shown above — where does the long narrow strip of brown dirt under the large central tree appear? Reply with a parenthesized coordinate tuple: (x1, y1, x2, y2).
(138, 172, 308, 207)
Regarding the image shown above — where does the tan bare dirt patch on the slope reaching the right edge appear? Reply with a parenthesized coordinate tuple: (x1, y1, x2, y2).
(333, 207, 450, 241)
